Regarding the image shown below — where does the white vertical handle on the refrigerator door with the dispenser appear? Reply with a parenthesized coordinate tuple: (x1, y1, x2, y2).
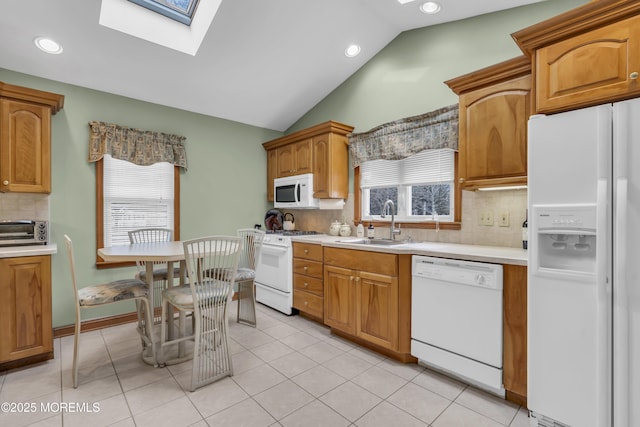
(596, 178, 611, 426)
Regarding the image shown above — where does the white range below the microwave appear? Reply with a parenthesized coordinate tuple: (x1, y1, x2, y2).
(255, 230, 320, 315)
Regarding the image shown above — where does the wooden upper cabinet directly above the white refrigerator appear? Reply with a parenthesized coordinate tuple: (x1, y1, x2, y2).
(513, 0, 640, 114)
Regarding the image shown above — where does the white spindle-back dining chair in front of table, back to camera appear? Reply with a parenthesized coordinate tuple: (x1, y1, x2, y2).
(158, 236, 242, 391)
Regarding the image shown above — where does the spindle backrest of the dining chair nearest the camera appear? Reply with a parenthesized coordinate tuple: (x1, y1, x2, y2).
(183, 236, 242, 315)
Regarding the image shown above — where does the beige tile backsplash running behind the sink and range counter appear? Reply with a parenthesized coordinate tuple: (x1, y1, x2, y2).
(291, 190, 527, 248)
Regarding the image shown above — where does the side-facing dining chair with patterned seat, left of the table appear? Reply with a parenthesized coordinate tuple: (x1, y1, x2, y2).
(64, 234, 155, 388)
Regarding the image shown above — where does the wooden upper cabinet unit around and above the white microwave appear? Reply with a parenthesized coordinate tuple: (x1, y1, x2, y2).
(262, 121, 353, 201)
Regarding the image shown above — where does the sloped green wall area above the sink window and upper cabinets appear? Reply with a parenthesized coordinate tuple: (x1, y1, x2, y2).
(287, 0, 588, 133)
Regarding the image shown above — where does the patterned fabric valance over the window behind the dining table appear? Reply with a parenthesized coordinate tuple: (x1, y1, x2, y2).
(89, 121, 187, 170)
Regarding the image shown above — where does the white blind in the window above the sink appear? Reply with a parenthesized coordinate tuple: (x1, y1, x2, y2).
(360, 149, 454, 188)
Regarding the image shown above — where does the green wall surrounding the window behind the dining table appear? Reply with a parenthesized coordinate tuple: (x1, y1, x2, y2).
(0, 68, 282, 327)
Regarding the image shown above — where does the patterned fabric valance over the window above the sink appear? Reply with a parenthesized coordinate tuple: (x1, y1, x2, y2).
(349, 104, 458, 168)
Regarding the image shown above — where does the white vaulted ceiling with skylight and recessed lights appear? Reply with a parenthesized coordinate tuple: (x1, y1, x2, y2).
(0, 0, 541, 131)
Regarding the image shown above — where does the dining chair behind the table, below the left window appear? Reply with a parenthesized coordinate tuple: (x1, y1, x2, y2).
(129, 228, 180, 324)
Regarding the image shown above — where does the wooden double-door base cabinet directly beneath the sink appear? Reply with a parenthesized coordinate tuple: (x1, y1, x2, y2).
(324, 247, 415, 362)
